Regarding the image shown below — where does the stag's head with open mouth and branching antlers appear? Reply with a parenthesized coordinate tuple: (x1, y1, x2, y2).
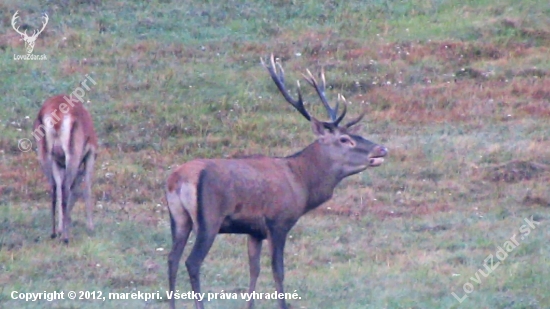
(261, 55, 388, 178)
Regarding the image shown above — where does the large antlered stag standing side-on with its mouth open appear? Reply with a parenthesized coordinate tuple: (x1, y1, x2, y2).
(166, 55, 388, 309)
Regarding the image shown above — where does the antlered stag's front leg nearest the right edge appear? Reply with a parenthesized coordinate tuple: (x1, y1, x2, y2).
(269, 230, 288, 309)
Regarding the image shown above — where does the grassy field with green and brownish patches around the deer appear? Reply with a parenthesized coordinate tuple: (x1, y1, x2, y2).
(0, 0, 550, 309)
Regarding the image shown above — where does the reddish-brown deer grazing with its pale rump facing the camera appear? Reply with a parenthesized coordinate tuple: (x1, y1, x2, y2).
(33, 95, 97, 243)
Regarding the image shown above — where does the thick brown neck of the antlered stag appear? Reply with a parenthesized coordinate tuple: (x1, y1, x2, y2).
(285, 142, 342, 212)
